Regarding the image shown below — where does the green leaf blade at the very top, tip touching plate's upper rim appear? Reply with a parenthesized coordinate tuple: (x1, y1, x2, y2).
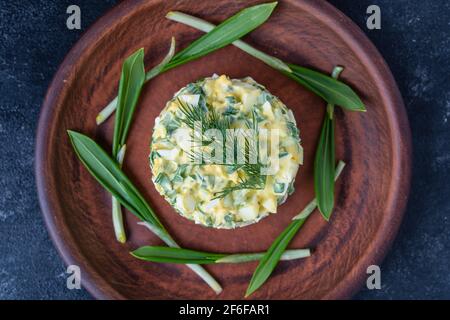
(165, 2, 277, 70)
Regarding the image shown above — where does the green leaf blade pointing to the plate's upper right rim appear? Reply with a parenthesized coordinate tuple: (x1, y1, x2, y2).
(286, 64, 366, 111)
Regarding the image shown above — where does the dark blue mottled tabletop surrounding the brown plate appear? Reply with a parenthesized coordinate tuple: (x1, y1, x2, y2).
(0, 0, 450, 299)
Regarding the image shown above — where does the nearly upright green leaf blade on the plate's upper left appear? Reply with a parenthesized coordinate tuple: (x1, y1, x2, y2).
(113, 48, 145, 157)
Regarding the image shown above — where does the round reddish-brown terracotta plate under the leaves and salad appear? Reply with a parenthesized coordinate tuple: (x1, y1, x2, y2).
(36, 0, 411, 299)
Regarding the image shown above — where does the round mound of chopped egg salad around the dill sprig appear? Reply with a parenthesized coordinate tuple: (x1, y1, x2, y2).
(149, 75, 303, 229)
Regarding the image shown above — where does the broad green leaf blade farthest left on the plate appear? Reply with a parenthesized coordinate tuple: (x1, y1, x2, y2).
(67, 130, 164, 230)
